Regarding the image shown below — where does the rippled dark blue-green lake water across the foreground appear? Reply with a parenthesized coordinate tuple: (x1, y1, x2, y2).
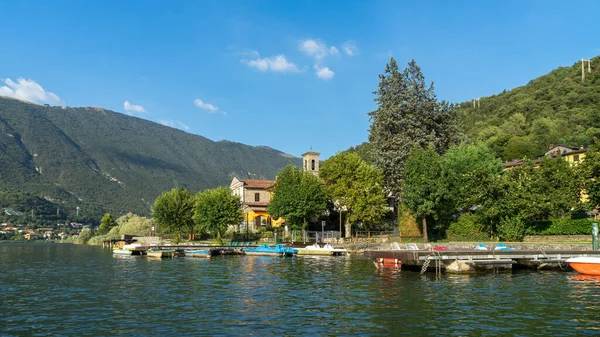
(0, 243, 600, 336)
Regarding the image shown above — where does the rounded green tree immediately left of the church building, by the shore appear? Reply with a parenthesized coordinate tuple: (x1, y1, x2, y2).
(194, 187, 244, 240)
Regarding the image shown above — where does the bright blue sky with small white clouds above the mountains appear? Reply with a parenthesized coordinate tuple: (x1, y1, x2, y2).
(0, 0, 600, 158)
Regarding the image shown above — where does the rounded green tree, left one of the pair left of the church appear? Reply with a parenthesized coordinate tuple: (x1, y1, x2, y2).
(152, 188, 196, 236)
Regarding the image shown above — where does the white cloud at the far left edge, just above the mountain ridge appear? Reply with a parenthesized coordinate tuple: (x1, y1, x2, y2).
(0, 78, 65, 106)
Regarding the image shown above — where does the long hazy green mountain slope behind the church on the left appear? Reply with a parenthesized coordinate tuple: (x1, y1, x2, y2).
(0, 97, 301, 217)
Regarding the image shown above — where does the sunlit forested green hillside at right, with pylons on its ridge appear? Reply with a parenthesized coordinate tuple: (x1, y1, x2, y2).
(459, 56, 600, 160)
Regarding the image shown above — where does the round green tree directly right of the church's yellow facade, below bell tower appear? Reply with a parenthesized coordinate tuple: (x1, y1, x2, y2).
(267, 165, 327, 226)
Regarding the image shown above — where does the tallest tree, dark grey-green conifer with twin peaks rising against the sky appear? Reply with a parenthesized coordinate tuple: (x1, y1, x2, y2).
(369, 58, 457, 205)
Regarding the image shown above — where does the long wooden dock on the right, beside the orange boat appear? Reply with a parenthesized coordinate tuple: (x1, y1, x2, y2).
(364, 250, 600, 273)
